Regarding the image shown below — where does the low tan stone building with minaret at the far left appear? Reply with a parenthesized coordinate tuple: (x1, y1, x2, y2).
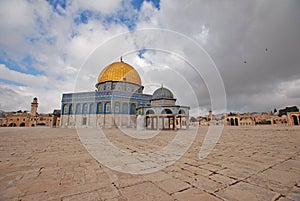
(0, 97, 60, 127)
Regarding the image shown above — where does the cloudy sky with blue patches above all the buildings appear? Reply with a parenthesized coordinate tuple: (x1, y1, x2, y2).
(0, 0, 300, 115)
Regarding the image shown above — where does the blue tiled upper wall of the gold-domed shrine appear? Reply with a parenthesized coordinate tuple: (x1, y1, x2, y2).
(61, 91, 152, 115)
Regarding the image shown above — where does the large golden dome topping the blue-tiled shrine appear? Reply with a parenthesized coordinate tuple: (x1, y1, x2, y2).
(98, 60, 142, 85)
